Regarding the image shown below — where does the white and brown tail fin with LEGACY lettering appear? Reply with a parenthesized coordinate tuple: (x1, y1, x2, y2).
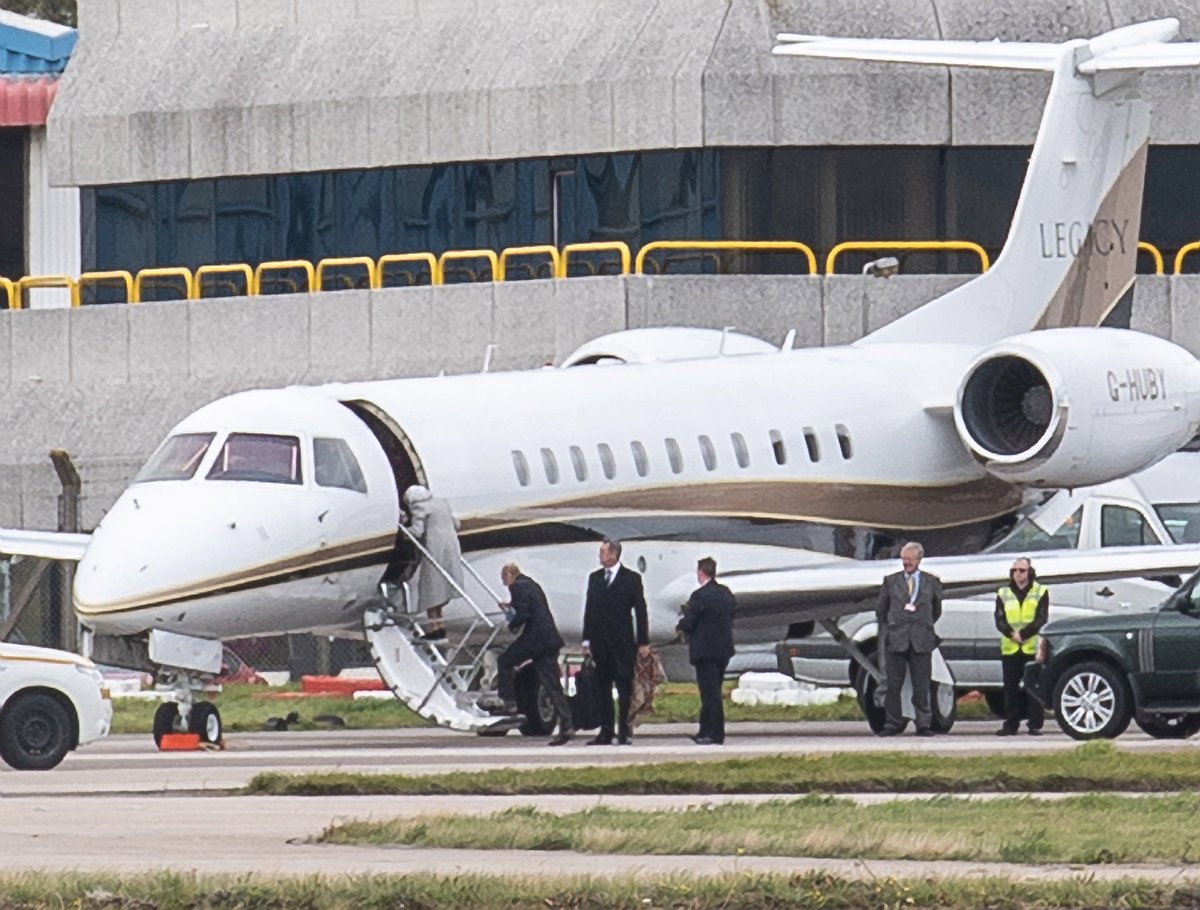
(775, 19, 1200, 345)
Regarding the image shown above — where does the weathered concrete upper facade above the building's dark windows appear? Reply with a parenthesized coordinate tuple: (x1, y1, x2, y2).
(49, 0, 1200, 185)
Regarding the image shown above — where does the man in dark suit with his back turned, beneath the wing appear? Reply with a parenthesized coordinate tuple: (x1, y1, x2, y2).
(676, 556, 737, 746)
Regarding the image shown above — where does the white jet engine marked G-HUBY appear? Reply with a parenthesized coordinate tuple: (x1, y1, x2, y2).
(954, 328, 1200, 487)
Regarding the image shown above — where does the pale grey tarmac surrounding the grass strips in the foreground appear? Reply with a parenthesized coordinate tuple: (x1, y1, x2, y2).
(0, 722, 1200, 881)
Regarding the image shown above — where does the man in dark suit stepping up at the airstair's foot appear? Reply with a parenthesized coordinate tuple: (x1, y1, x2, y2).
(497, 563, 575, 746)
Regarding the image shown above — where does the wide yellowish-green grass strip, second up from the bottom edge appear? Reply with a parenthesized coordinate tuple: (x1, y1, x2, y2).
(320, 794, 1200, 864)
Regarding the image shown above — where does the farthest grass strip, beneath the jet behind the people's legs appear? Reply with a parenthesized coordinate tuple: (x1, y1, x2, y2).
(113, 682, 988, 734)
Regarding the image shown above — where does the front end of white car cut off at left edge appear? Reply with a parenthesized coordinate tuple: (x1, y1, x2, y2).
(0, 642, 113, 771)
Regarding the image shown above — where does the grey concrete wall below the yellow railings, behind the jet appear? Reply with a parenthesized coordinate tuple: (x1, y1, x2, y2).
(0, 276, 1200, 528)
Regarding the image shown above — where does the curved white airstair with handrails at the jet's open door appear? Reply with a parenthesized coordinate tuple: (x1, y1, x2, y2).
(364, 526, 523, 734)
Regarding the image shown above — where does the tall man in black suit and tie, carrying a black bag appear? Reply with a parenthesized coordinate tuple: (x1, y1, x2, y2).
(583, 539, 650, 746)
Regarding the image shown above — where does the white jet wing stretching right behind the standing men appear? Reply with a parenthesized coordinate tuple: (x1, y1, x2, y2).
(700, 545, 1200, 622)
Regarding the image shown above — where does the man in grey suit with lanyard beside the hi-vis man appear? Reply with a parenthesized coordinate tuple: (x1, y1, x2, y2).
(875, 541, 942, 736)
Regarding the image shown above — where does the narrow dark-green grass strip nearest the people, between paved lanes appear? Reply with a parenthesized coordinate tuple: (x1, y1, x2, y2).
(247, 741, 1200, 796)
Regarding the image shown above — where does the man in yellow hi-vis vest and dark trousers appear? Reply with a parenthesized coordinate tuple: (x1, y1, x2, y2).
(996, 556, 1050, 736)
